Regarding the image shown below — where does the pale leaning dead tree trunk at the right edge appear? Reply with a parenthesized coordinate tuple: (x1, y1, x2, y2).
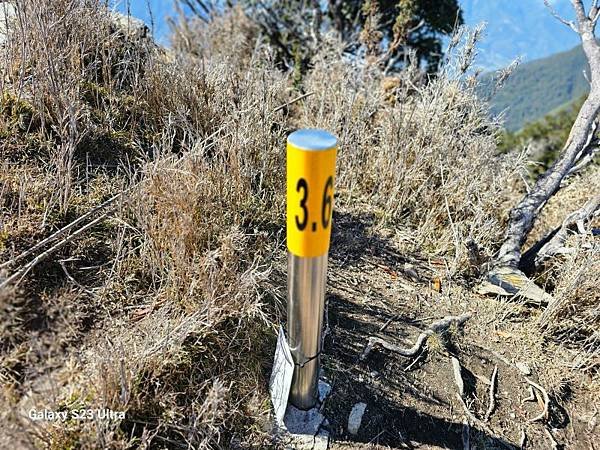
(495, 0, 600, 270)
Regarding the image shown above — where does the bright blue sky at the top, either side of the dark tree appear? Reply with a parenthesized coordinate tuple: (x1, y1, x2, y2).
(113, 0, 589, 69)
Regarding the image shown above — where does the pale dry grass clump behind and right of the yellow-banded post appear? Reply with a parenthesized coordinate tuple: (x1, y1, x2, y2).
(298, 33, 521, 274)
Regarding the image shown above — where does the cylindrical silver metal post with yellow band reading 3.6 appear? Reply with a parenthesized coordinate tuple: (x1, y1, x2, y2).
(287, 129, 337, 410)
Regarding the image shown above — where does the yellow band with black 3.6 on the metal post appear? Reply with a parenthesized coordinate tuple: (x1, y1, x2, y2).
(287, 141, 337, 257)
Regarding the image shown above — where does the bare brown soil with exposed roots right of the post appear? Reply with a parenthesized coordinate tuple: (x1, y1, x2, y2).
(314, 207, 600, 449)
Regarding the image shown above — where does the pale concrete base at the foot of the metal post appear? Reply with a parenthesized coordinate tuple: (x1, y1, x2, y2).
(277, 380, 331, 450)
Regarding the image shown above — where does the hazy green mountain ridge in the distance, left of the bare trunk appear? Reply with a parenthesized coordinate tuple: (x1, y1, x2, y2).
(480, 46, 589, 131)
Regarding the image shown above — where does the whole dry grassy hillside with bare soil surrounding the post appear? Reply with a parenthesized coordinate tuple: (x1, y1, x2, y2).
(0, 0, 600, 450)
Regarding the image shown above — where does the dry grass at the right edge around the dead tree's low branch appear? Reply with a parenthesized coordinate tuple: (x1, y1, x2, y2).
(528, 166, 600, 373)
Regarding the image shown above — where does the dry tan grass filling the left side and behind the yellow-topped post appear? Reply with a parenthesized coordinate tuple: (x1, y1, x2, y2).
(0, 0, 597, 449)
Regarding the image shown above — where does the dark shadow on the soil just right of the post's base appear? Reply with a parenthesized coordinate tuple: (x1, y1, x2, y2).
(323, 294, 516, 449)
